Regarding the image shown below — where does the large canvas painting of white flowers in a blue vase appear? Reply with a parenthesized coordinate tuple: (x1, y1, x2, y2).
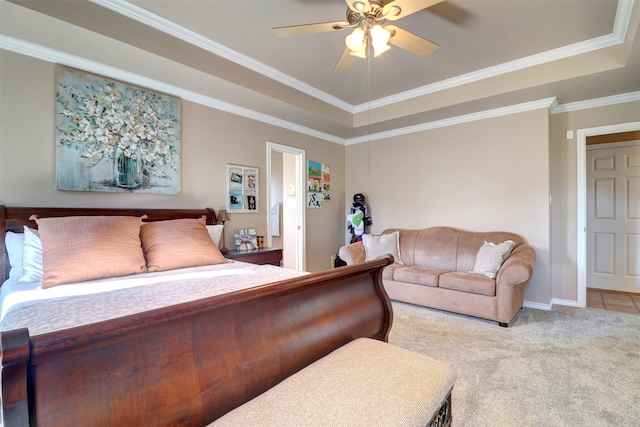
(56, 66, 180, 194)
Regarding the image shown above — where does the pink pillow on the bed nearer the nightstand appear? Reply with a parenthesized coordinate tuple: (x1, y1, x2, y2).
(140, 218, 228, 272)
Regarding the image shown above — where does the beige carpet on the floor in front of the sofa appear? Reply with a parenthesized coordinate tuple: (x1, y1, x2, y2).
(389, 302, 640, 427)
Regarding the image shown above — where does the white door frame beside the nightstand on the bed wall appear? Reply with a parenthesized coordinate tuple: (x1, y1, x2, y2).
(266, 141, 307, 271)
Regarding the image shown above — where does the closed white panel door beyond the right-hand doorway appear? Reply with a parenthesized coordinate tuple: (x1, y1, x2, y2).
(587, 141, 640, 292)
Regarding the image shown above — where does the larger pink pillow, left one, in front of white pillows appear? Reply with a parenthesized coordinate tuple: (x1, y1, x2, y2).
(32, 215, 147, 288)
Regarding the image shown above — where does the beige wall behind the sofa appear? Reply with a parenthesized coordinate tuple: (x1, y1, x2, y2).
(346, 109, 551, 304)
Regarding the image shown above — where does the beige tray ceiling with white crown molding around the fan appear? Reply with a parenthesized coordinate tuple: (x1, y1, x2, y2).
(5, 0, 640, 144)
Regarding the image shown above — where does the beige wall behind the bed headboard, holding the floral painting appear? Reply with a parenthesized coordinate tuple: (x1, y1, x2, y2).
(0, 51, 345, 271)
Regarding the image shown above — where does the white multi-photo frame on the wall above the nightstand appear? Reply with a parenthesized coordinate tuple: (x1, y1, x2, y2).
(225, 164, 260, 213)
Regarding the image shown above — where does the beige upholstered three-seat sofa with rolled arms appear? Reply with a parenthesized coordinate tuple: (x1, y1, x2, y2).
(338, 227, 535, 327)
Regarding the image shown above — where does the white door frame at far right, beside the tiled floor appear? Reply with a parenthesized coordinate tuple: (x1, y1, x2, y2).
(576, 122, 640, 307)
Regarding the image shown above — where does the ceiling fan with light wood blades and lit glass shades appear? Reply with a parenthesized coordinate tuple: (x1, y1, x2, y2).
(273, 0, 443, 71)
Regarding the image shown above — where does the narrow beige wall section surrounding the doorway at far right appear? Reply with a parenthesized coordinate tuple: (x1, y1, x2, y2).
(549, 102, 640, 302)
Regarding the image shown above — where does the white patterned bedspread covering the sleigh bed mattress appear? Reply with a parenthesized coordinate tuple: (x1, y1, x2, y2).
(0, 262, 307, 335)
